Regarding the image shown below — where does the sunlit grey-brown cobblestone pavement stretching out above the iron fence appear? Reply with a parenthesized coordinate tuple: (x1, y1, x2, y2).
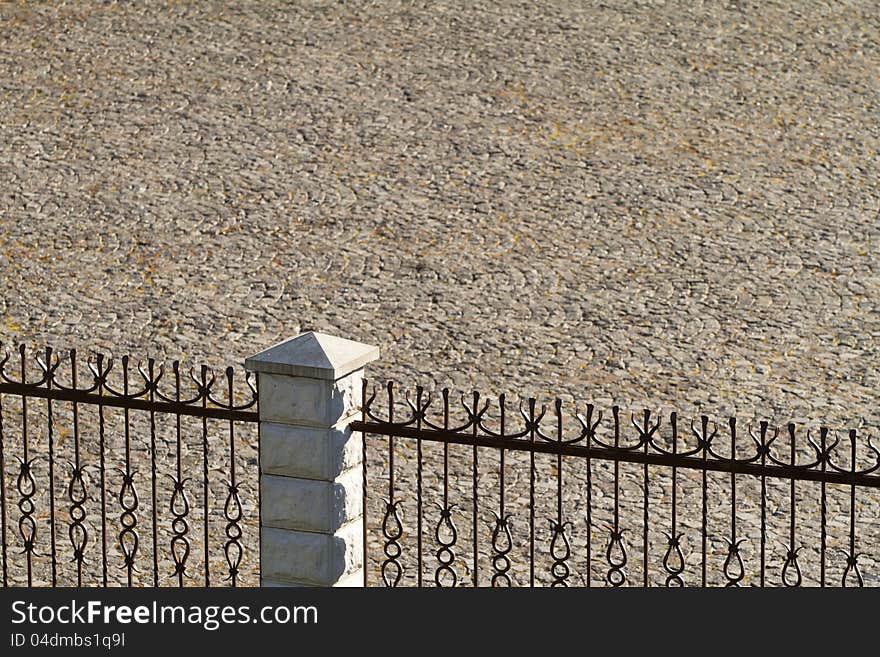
(0, 1, 880, 584)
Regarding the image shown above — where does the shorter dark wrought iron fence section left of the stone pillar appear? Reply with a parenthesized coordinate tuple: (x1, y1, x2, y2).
(0, 345, 259, 586)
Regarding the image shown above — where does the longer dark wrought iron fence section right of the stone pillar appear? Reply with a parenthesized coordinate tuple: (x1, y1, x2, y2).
(352, 381, 880, 586)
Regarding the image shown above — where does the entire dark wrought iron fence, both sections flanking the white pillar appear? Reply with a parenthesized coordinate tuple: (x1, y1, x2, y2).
(6, 338, 880, 586)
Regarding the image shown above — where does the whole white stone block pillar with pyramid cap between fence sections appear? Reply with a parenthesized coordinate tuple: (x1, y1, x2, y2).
(245, 331, 379, 586)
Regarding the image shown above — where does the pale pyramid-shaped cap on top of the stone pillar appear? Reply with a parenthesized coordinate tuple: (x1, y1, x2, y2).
(244, 331, 379, 381)
